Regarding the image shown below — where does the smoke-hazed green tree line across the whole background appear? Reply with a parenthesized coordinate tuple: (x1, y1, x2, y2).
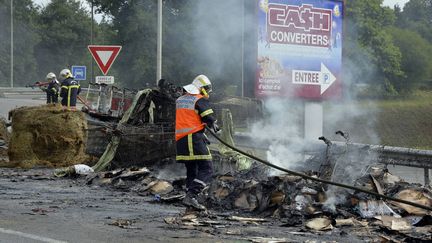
(0, 0, 432, 97)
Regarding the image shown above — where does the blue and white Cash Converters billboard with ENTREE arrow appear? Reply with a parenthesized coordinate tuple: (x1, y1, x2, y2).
(255, 0, 344, 100)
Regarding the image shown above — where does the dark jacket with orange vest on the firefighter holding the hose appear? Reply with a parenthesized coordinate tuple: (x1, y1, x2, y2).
(176, 94, 215, 162)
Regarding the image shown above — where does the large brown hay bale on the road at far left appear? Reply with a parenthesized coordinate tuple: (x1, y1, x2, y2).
(8, 105, 90, 168)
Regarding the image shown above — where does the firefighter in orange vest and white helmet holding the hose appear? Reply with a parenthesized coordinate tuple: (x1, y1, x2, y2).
(175, 75, 219, 210)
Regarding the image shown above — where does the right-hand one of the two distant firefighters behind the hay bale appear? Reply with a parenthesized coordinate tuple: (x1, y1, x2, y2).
(60, 69, 81, 111)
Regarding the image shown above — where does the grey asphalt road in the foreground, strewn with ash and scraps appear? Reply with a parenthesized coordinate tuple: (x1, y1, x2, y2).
(0, 168, 377, 243)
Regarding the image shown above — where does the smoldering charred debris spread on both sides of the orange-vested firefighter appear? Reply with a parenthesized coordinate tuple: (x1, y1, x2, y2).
(80, 162, 432, 241)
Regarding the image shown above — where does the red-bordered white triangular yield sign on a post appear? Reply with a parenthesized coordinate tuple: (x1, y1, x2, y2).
(88, 45, 121, 75)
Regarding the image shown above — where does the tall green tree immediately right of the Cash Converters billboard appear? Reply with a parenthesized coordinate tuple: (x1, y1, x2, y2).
(345, 0, 404, 95)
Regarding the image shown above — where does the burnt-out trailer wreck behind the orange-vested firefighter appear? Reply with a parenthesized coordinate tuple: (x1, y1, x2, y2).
(86, 80, 262, 168)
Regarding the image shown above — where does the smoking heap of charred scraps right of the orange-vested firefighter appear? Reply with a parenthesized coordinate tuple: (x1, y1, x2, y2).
(206, 167, 432, 240)
